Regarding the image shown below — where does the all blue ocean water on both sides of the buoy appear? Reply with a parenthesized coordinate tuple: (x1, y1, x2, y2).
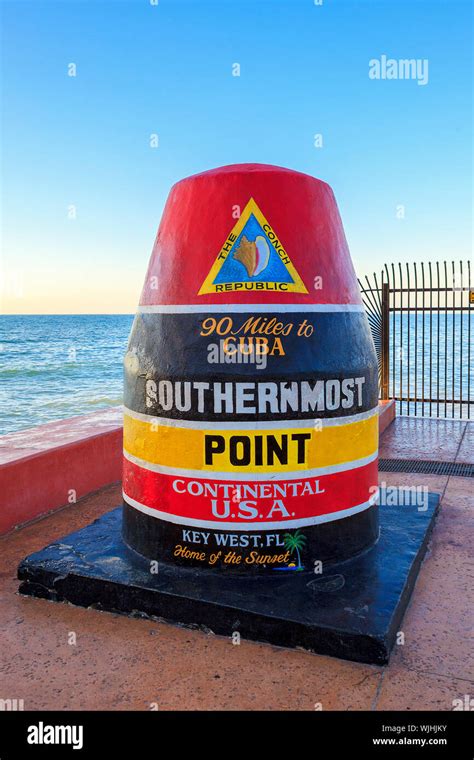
(0, 310, 474, 434)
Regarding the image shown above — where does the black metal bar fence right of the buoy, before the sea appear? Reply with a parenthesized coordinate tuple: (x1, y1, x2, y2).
(359, 261, 474, 419)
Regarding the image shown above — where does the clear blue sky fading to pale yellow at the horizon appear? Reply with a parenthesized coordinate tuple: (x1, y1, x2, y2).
(1, 0, 472, 313)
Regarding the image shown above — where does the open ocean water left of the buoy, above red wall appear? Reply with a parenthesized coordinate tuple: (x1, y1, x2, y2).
(0, 314, 133, 435)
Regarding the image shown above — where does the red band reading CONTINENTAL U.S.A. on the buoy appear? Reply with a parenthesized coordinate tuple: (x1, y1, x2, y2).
(123, 459, 377, 530)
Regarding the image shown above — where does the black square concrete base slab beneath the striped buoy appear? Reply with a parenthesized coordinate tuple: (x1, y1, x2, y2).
(18, 489, 439, 665)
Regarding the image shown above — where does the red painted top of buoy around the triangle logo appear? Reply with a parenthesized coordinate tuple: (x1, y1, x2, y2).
(140, 164, 361, 306)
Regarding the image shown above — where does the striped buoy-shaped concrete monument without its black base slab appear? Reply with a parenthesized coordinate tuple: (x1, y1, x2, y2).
(123, 164, 378, 573)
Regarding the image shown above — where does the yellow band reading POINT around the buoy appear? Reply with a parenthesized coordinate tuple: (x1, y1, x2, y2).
(124, 406, 378, 473)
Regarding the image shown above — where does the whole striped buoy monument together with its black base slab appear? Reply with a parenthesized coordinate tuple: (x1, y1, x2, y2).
(19, 164, 439, 664)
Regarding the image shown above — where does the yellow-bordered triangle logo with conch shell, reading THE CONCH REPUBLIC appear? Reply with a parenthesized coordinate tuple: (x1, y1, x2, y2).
(198, 198, 308, 296)
